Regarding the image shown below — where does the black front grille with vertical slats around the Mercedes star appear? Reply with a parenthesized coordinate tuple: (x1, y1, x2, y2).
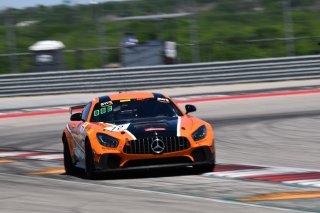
(123, 136, 190, 154)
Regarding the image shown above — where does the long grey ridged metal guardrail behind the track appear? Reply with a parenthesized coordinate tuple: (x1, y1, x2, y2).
(0, 55, 320, 97)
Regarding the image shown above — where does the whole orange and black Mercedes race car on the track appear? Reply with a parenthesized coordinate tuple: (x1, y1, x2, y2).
(62, 92, 215, 178)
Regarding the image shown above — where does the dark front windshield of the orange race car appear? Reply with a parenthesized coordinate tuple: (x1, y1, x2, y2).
(91, 98, 182, 123)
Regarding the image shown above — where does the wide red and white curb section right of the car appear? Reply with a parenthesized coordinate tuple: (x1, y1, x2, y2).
(203, 164, 320, 187)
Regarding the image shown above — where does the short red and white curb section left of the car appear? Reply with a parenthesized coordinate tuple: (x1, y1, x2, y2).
(0, 150, 63, 160)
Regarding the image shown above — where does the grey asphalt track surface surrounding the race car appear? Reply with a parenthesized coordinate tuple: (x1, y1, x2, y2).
(0, 87, 320, 213)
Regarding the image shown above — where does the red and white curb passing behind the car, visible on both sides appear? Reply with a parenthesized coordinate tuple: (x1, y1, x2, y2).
(0, 150, 320, 188)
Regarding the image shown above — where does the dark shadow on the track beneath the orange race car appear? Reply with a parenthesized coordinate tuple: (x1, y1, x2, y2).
(62, 167, 199, 180)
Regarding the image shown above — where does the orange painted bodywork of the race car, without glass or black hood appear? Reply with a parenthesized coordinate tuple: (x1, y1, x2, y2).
(64, 92, 215, 169)
